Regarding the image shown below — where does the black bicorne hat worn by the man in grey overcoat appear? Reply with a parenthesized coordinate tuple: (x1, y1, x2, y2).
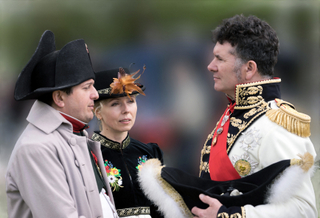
(14, 30, 95, 101)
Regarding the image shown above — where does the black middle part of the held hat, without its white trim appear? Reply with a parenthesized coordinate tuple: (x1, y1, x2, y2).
(161, 160, 290, 210)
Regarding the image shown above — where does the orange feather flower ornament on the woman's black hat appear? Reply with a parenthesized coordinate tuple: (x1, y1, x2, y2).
(110, 66, 146, 99)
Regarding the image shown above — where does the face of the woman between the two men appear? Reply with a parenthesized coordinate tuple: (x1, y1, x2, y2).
(97, 96, 137, 134)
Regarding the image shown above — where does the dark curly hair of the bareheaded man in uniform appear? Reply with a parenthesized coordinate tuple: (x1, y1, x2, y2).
(212, 15, 279, 76)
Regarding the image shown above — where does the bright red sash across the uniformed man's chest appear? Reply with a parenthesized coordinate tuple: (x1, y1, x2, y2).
(209, 103, 241, 181)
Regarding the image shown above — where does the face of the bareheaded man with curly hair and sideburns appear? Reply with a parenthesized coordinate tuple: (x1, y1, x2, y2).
(208, 42, 244, 97)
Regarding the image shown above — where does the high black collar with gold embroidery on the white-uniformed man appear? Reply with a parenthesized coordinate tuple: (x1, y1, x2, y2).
(227, 78, 281, 109)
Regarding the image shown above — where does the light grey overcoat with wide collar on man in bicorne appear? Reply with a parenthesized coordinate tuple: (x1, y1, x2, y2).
(6, 101, 117, 218)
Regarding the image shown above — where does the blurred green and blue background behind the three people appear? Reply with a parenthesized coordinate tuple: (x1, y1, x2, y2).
(0, 0, 320, 218)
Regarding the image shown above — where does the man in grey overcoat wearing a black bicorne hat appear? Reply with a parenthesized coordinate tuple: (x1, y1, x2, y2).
(6, 31, 118, 218)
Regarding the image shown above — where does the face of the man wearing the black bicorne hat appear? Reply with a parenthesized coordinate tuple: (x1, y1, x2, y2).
(62, 79, 99, 123)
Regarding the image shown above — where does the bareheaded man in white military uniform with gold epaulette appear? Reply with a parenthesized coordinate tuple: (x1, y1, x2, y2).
(192, 15, 318, 218)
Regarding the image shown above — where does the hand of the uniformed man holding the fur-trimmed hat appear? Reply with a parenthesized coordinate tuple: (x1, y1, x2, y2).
(191, 194, 222, 218)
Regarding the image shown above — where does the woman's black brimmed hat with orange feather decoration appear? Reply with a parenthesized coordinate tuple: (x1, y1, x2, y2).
(94, 67, 145, 100)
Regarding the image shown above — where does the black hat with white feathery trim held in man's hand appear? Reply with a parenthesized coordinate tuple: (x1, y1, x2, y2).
(138, 153, 314, 217)
